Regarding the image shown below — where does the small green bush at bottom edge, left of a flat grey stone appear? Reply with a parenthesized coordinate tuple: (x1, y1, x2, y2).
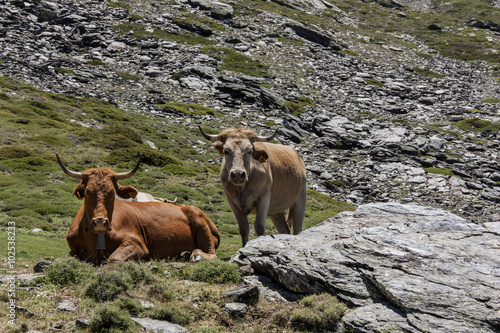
(89, 304, 135, 333)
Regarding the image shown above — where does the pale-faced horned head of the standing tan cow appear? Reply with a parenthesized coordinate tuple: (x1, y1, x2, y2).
(198, 126, 278, 186)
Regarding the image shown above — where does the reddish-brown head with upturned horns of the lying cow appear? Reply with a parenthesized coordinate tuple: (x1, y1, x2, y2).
(56, 154, 142, 233)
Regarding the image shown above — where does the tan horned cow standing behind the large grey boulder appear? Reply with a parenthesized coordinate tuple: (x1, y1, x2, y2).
(199, 127, 307, 246)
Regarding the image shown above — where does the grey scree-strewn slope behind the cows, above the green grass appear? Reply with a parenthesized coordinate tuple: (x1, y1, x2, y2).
(0, 0, 500, 223)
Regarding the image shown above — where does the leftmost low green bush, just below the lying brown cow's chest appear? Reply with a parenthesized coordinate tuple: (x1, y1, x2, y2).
(45, 258, 95, 286)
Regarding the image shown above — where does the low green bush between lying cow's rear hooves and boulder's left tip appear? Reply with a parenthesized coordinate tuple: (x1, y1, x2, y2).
(183, 259, 242, 283)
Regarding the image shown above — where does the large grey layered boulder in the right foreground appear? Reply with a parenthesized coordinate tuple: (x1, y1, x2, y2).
(233, 203, 500, 332)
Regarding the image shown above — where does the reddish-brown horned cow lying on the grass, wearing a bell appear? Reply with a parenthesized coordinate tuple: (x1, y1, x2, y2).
(56, 154, 220, 263)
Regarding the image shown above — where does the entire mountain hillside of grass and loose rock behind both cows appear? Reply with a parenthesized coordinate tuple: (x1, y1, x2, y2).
(0, 0, 500, 233)
